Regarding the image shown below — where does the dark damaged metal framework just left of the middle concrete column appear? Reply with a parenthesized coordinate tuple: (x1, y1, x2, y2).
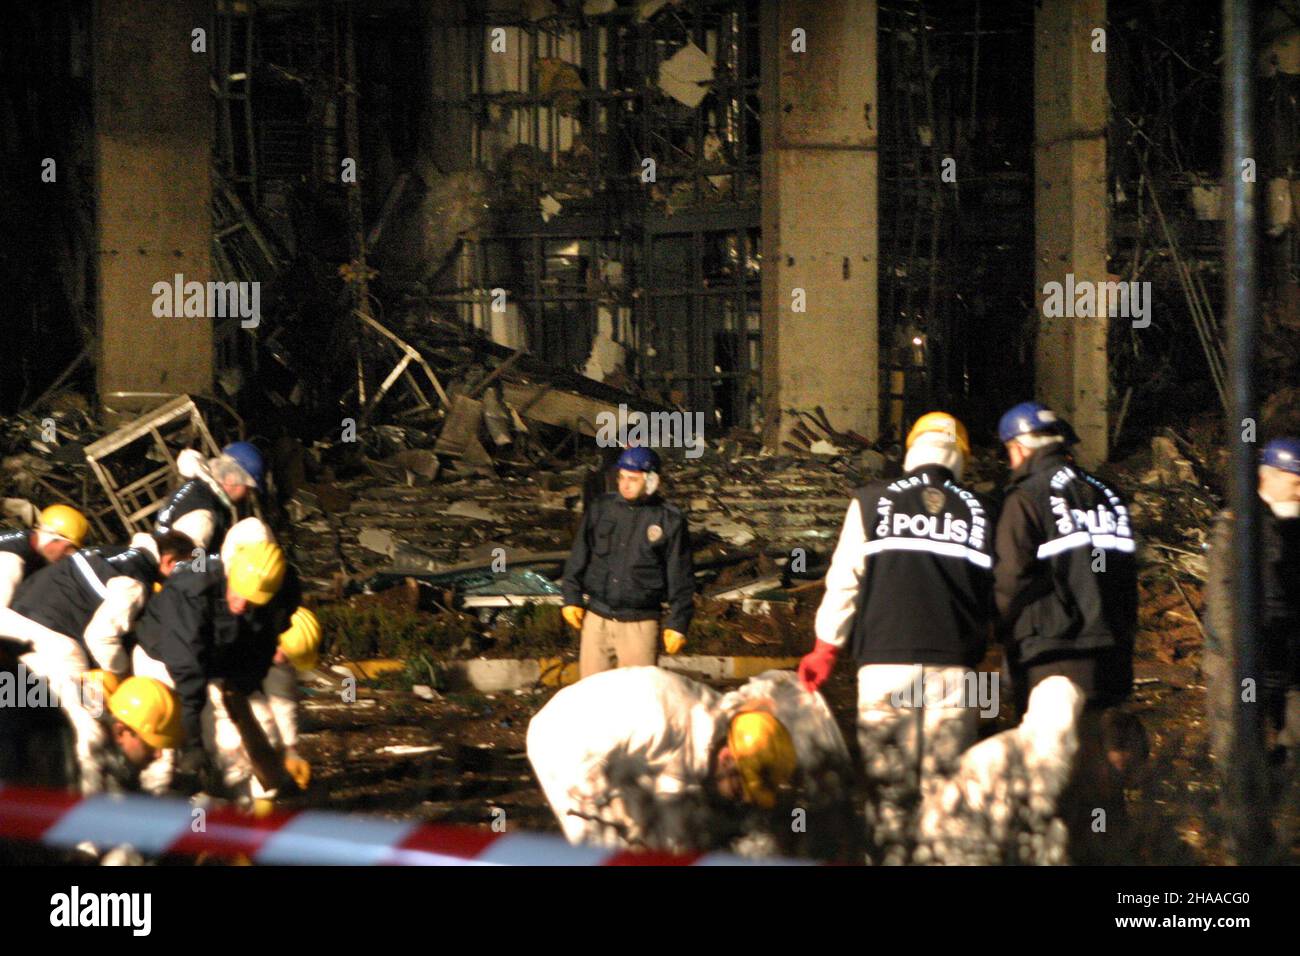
(430, 0, 762, 425)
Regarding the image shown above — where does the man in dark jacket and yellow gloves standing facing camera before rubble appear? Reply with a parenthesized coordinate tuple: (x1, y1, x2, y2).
(563, 447, 696, 678)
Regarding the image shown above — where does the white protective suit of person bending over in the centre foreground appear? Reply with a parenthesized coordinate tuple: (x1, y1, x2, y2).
(528, 667, 848, 848)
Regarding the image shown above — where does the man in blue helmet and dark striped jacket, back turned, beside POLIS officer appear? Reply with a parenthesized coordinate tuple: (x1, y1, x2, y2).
(993, 402, 1141, 862)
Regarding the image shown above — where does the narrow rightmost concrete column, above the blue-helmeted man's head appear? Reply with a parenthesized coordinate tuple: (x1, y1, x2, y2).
(1034, 0, 1110, 464)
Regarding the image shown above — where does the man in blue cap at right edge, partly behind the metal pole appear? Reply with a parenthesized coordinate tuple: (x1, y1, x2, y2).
(1204, 437, 1300, 766)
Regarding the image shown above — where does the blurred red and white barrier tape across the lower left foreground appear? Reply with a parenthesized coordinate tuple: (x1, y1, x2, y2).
(0, 784, 797, 866)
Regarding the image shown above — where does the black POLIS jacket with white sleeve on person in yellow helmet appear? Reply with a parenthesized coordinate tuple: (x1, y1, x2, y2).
(816, 464, 993, 667)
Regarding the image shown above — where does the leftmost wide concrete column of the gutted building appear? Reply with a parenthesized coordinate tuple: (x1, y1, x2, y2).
(92, 0, 211, 410)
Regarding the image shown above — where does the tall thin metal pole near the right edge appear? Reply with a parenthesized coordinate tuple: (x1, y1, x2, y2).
(1223, 0, 1271, 864)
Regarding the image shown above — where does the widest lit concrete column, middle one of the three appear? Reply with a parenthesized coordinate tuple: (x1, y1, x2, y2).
(761, 0, 880, 446)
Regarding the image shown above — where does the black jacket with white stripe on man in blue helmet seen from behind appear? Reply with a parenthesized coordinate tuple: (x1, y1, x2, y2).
(995, 445, 1138, 683)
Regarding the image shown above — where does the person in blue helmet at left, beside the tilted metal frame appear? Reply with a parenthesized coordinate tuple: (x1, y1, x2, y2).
(157, 441, 267, 553)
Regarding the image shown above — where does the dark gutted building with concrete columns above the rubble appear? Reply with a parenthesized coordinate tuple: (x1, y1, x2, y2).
(3, 0, 1295, 460)
